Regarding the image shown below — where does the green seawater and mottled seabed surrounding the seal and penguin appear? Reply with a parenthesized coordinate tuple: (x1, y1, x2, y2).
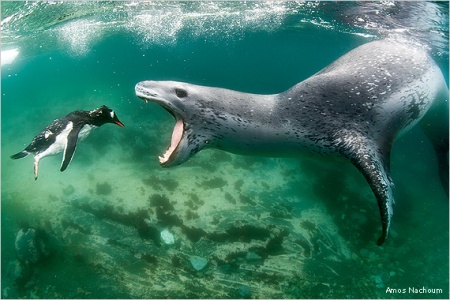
(0, 1, 449, 299)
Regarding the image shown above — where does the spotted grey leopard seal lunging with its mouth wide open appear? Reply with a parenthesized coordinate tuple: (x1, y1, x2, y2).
(135, 39, 448, 245)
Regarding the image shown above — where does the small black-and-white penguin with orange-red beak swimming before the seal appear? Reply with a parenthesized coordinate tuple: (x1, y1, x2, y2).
(11, 105, 124, 180)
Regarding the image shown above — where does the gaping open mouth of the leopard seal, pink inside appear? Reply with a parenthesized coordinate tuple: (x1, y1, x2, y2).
(136, 84, 185, 166)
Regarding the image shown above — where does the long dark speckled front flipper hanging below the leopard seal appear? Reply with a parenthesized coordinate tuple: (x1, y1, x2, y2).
(336, 131, 394, 246)
